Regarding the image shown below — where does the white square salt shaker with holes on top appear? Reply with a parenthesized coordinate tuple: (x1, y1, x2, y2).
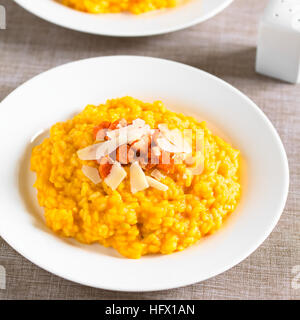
(256, 0, 300, 83)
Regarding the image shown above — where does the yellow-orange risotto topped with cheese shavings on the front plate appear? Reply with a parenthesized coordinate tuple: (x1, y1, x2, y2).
(31, 97, 241, 258)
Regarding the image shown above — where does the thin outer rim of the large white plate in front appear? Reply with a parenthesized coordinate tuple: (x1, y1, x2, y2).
(0, 55, 290, 292)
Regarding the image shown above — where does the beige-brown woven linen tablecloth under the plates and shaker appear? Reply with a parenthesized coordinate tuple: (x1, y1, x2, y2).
(0, 0, 300, 299)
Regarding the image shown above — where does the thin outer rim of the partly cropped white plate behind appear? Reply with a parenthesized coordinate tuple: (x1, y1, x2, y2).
(14, 0, 234, 38)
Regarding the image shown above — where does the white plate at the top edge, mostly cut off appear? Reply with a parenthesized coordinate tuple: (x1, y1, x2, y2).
(15, 0, 233, 37)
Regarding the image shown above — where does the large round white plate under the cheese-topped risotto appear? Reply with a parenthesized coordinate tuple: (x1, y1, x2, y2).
(0, 56, 289, 291)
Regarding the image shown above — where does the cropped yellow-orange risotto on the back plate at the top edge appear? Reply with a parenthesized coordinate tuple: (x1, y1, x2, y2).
(58, 0, 180, 14)
